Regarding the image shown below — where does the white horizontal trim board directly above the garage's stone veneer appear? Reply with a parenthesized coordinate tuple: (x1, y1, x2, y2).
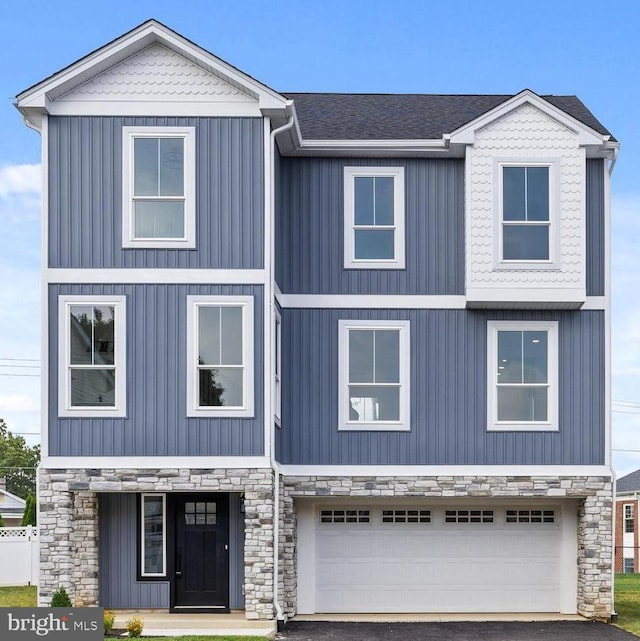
(280, 465, 612, 478)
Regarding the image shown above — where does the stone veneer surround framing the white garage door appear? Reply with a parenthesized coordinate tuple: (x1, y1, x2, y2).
(279, 476, 613, 619)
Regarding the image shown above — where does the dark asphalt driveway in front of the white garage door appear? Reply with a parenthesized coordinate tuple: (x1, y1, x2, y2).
(277, 621, 638, 641)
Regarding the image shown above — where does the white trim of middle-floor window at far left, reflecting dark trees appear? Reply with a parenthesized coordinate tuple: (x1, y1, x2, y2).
(58, 295, 127, 418)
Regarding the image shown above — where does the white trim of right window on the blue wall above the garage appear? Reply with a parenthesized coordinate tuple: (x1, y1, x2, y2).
(487, 321, 559, 432)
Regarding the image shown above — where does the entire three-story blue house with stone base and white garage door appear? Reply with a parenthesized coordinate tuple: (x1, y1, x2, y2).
(17, 20, 618, 620)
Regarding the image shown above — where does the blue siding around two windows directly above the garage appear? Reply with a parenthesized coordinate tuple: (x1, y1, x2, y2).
(276, 309, 605, 465)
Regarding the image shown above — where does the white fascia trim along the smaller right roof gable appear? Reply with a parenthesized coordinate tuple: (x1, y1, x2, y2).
(448, 89, 609, 146)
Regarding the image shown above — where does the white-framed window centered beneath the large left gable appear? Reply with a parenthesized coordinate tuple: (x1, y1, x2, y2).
(122, 127, 196, 249)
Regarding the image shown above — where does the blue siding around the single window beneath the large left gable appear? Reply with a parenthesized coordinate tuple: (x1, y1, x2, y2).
(48, 116, 264, 269)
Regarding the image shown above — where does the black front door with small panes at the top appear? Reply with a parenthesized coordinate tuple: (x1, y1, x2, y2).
(174, 494, 229, 612)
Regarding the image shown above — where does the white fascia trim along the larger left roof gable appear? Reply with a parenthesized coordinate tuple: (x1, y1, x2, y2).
(17, 20, 288, 109)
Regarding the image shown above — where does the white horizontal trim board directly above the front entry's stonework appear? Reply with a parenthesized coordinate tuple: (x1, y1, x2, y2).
(40, 456, 271, 470)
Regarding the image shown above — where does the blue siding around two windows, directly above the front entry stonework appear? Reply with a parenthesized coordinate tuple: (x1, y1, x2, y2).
(49, 284, 264, 456)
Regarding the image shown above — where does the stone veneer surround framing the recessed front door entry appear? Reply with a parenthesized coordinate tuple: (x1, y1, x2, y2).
(38, 468, 274, 619)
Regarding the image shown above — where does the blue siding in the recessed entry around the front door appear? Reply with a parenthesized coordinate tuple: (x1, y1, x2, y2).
(98, 492, 244, 609)
